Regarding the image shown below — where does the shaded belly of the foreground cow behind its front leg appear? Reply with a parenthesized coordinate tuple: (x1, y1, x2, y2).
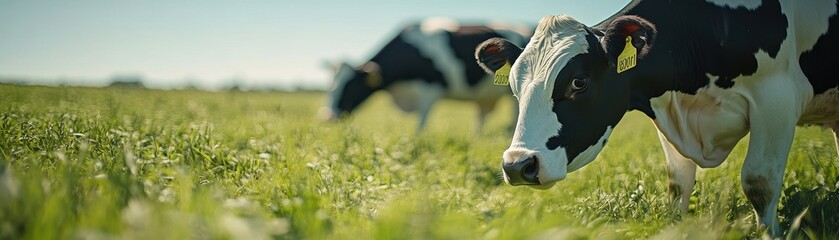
(798, 88, 839, 124)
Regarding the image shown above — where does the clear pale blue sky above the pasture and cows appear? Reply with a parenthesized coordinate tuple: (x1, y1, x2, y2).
(0, 0, 629, 88)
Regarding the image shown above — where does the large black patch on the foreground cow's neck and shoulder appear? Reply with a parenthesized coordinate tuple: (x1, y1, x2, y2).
(596, 0, 789, 119)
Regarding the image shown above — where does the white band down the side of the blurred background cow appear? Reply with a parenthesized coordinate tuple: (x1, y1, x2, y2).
(402, 18, 472, 96)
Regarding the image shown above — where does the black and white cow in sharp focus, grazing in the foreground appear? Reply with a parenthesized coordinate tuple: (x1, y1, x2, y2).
(476, 0, 839, 234)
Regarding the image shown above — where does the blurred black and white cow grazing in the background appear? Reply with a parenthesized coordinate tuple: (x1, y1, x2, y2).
(324, 18, 532, 130)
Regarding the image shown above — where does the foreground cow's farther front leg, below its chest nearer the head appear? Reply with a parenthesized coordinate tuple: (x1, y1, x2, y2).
(658, 131, 696, 213)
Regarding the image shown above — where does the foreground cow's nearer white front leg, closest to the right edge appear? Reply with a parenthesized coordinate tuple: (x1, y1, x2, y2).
(740, 89, 804, 236)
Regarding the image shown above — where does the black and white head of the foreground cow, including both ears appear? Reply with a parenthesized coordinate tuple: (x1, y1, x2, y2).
(475, 16, 656, 188)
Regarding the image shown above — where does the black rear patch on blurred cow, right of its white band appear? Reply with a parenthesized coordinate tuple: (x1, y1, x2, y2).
(449, 26, 503, 87)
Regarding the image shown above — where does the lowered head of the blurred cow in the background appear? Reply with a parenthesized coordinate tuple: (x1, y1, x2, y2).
(322, 62, 383, 120)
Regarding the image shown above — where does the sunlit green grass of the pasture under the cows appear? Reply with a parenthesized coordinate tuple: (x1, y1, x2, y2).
(0, 85, 839, 239)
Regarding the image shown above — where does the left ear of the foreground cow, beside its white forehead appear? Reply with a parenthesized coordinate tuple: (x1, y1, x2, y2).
(475, 38, 521, 73)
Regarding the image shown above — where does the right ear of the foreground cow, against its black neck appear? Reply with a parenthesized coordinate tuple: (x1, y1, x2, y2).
(601, 15, 657, 64)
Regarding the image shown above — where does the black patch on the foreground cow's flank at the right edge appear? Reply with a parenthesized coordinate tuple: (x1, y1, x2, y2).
(798, 2, 839, 94)
